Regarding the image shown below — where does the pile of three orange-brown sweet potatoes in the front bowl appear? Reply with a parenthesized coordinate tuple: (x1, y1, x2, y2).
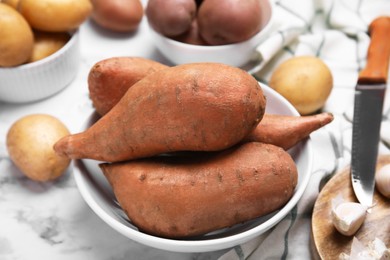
(50, 57, 333, 238)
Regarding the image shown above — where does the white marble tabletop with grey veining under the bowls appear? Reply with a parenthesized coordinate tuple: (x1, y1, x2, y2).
(0, 19, 229, 260)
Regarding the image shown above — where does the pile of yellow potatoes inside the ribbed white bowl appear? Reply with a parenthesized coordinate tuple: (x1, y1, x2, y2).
(0, 0, 92, 67)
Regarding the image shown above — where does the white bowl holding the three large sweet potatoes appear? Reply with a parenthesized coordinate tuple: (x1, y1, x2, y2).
(74, 85, 313, 252)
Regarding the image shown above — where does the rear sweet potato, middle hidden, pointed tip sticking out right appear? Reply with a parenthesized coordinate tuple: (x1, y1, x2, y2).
(88, 57, 333, 150)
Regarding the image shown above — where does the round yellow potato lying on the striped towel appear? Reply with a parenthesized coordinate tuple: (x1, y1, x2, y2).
(269, 56, 333, 115)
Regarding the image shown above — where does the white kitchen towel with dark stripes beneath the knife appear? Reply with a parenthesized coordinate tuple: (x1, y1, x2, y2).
(220, 0, 390, 260)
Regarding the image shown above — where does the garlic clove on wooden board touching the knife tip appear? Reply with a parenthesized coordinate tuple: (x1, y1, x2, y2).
(332, 202, 367, 236)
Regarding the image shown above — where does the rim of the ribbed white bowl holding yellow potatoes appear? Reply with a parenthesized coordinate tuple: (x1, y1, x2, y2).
(0, 29, 79, 72)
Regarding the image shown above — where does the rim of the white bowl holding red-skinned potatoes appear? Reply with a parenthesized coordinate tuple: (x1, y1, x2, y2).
(149, 0, 275, 51)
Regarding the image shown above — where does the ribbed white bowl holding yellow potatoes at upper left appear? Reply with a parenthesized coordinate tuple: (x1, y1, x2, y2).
(0, 30, 80, 103)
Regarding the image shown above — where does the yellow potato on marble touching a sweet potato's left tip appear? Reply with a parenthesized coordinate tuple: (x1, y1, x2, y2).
(7, 114, 70, 182)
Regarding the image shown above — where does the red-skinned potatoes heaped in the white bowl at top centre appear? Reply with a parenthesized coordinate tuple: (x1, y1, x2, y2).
(145, 0, 271, 45)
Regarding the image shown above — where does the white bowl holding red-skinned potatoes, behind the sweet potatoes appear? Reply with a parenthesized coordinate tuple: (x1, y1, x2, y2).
(149, 1, 274, 67)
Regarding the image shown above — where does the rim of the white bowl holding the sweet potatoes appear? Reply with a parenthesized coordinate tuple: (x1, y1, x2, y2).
(73, 84, 313, 252)
